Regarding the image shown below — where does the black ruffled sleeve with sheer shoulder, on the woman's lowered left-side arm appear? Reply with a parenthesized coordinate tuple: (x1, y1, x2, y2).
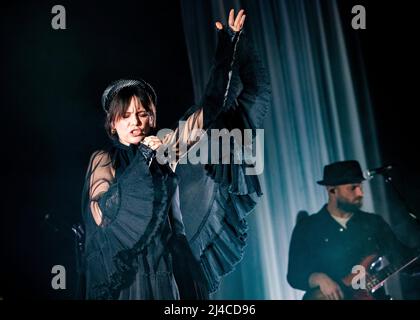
(83, 145, 175, 299)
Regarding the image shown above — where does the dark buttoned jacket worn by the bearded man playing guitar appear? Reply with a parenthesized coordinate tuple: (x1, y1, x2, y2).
(287, 205, 410, 291)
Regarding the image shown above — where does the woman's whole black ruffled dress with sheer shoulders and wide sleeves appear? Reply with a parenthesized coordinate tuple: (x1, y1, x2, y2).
(82, 28, 270, 299)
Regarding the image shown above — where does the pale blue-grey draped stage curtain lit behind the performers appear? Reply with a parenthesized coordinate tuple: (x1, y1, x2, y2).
(181, 0, 399, 299)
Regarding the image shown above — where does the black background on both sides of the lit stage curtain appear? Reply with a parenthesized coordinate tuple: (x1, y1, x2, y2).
(0, 1, 420, 299)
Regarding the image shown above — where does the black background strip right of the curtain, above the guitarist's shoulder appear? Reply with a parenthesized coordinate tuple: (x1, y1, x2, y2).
(340, 1, 420, 211)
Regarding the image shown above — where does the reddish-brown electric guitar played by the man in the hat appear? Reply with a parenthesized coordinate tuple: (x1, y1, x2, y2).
(302, 254, 420, 300)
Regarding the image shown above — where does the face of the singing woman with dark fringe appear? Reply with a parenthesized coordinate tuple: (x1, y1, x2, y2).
(113, 96, 150, 146)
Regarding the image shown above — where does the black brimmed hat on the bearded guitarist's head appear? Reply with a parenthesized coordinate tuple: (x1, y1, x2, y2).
(317, 160, 366, 186)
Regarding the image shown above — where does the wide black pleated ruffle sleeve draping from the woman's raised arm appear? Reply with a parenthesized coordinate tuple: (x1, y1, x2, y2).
(176, 30, 270, 292)
